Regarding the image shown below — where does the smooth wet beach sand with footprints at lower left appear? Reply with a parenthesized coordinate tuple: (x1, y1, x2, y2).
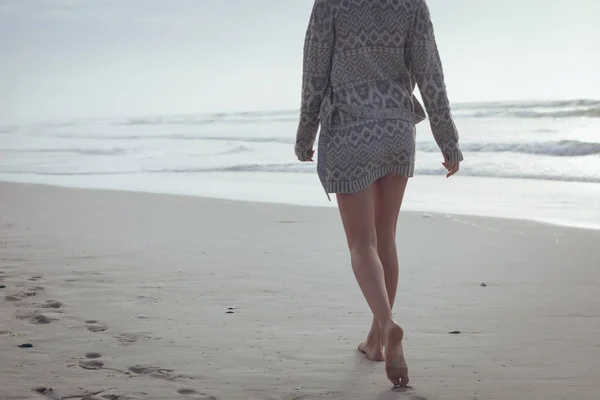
(0, 183, 600, 400)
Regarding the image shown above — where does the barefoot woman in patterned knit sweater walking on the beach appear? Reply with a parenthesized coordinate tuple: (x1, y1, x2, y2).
(295, 0, 463, 386)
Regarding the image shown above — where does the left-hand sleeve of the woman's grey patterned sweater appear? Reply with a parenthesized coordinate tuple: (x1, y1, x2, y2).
(294, 0, 335, 161)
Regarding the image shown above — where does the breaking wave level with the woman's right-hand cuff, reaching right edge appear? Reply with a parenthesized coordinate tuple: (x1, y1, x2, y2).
(417, 140, 600, 157)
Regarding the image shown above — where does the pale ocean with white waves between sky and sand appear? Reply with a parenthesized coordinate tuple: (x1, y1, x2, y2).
(0, 100, 600, 229)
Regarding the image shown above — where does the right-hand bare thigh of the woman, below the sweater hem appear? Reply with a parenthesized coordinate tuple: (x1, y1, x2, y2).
(374, 174, 409, 240)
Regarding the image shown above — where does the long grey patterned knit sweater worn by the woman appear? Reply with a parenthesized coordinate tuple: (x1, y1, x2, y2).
(295, 0, 463, 193)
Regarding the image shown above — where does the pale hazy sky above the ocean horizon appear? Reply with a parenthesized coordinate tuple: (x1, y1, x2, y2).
(0, 0, 600, 119)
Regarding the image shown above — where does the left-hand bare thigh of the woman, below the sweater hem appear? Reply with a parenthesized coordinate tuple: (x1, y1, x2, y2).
(337, 184, 377, 249)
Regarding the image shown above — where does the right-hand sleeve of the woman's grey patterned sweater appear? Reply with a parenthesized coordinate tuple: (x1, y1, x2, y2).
(407, 0, 463, 162)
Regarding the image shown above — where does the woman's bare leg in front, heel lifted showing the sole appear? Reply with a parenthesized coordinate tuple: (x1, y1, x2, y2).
(337, 180, 408, 386)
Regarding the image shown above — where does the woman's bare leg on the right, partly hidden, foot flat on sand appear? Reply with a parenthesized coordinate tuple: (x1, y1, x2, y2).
(358, 174, 408, 361)
